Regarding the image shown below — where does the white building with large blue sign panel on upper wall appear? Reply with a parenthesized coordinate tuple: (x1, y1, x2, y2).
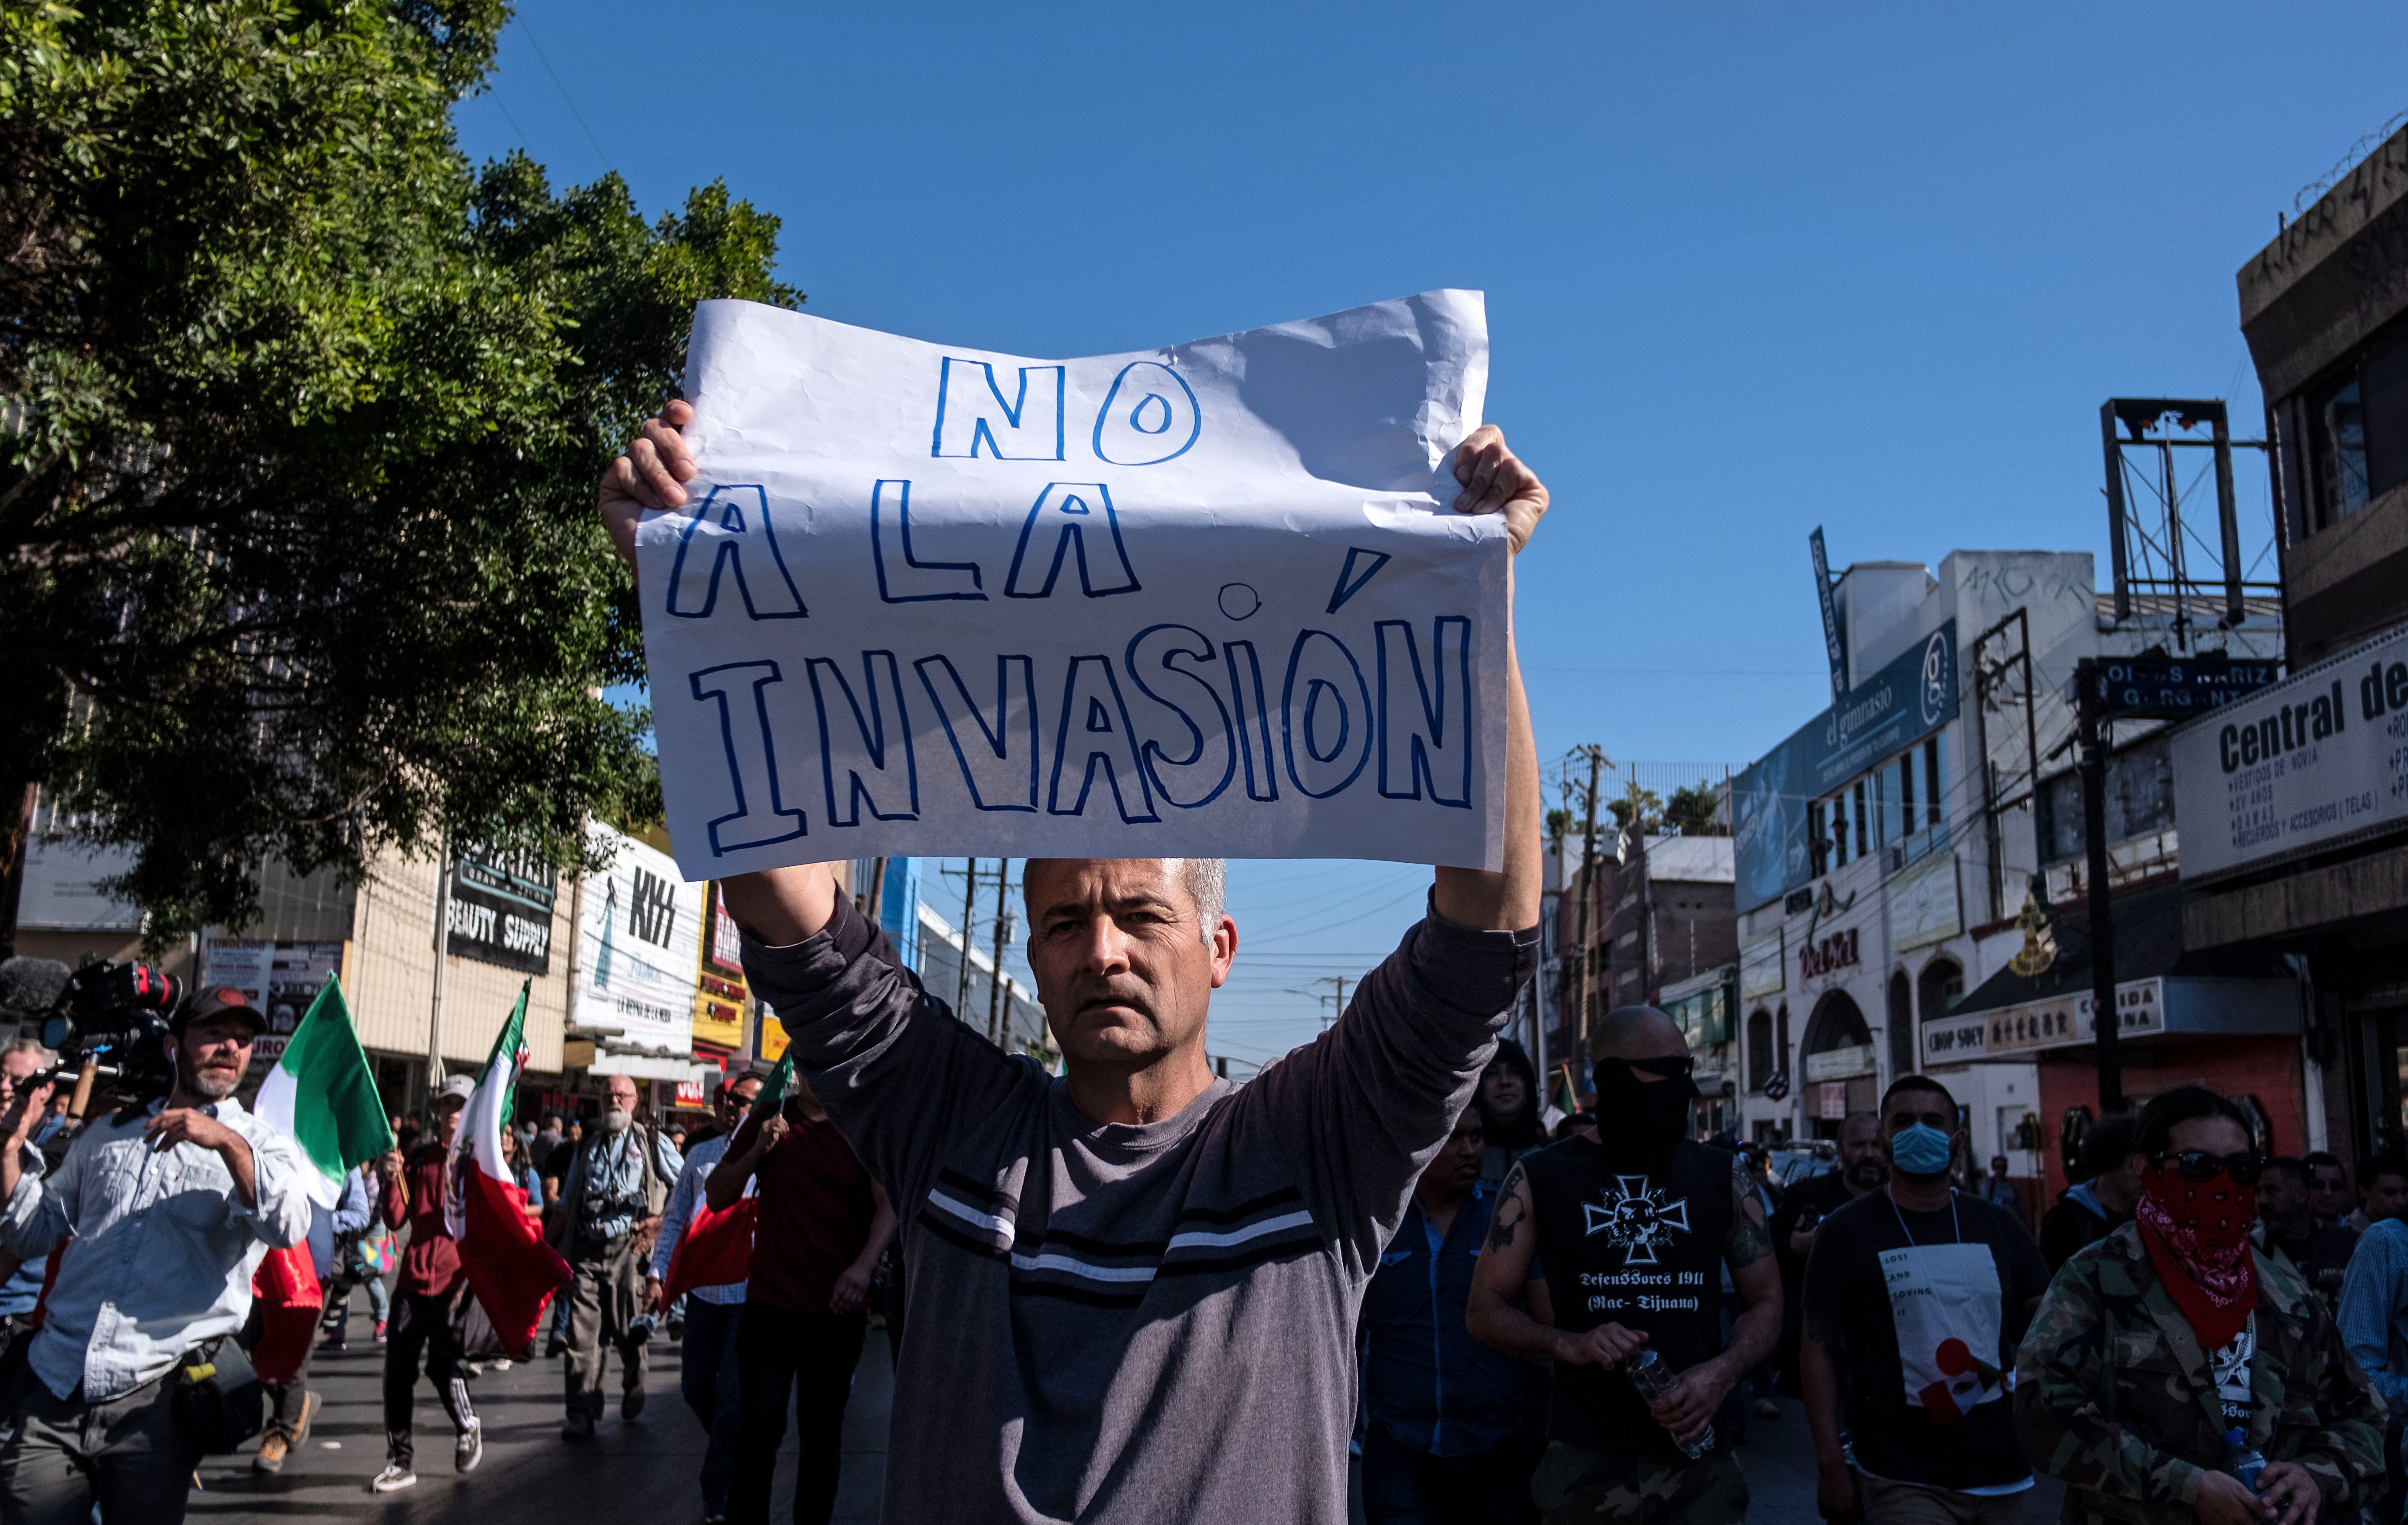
(1731, 552, 2302, 1202)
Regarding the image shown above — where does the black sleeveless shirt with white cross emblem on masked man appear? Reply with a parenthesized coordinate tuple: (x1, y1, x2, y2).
(1522, 1137, 1731, 1465)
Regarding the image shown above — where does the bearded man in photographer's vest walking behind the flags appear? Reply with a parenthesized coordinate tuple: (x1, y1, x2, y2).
(551, 1074, 686, 1441)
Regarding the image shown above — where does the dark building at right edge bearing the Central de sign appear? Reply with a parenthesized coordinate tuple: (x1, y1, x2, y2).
(2172, 130, 2408, 1151)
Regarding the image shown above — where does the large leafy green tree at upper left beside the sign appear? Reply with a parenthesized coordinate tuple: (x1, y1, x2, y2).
(0, 0, 802, 937)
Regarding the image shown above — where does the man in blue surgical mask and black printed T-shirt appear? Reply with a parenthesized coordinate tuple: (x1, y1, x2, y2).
(1799, 1074, 2049, 1525)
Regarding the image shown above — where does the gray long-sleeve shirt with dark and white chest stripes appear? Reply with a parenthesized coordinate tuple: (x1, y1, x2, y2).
(744, 896, 1536, 1525)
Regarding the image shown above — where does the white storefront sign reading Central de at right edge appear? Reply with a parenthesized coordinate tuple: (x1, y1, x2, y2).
(2172, 626, 2408, 879)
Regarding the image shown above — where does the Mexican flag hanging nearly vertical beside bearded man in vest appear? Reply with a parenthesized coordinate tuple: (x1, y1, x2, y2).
(443, 981, 571, 1356)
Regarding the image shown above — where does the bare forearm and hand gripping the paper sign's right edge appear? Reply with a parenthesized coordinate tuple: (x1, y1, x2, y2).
(1430, 424, 1546, 932)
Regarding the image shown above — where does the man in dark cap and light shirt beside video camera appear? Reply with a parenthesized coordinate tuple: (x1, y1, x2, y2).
(0, 985, 311, 1525)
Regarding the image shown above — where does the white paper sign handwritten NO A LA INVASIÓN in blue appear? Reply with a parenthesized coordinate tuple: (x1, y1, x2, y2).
(638, 291, 1507, 879)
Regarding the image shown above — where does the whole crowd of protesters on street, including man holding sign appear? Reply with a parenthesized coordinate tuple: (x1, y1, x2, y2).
(0, 402, 2408, 1525)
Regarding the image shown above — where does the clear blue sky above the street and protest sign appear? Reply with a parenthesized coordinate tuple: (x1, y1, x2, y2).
(457, 0, 2408, 1058)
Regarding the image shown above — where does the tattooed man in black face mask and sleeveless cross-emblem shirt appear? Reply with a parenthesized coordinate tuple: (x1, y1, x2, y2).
(1466, 1007, 1782, 1525)
